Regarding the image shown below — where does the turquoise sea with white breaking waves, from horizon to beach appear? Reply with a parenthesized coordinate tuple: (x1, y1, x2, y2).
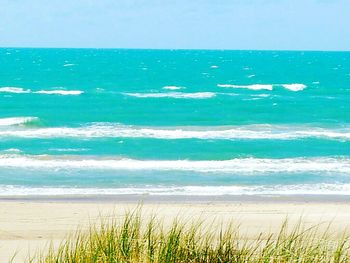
(0, 48, 350, 196)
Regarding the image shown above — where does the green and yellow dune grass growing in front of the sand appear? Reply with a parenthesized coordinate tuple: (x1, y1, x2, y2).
(29, 211, 350, 263)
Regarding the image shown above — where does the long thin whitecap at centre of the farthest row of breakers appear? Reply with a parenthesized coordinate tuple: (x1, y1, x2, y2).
(123, 92, 216, 99)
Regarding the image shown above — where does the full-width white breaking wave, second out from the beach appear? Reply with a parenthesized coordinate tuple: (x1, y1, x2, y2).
(0, 154, 350, 174)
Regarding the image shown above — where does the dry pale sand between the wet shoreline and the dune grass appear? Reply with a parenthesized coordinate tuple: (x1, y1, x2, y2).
(0, 201, 350, 262)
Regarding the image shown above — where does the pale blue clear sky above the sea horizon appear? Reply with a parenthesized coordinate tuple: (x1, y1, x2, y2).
(0, 0, 350, 50)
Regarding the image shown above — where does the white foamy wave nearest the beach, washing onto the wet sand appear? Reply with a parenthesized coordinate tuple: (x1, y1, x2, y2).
(0, 184, 350, 196)
